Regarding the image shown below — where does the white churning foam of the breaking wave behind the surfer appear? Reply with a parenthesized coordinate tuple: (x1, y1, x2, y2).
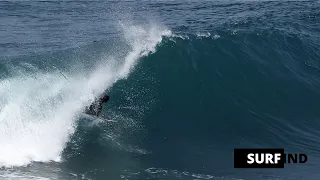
(0, 22, 171, 167)
